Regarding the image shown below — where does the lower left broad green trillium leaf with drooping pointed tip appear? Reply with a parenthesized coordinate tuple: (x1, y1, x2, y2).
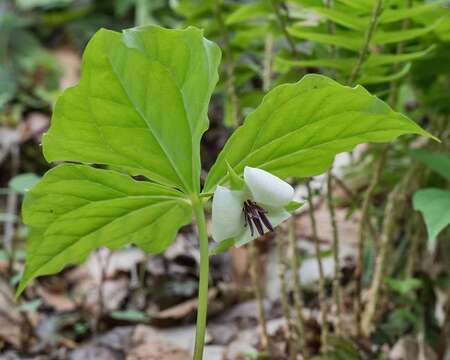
(18, 164, 192, 293)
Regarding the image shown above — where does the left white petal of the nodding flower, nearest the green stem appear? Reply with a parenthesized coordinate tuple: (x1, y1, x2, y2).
(212, 186, 244, 241)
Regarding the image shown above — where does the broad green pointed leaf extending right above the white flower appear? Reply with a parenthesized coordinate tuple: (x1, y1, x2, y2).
(204, 74, 430, 192)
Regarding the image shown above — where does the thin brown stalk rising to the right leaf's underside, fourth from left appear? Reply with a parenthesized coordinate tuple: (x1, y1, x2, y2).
(306, 181, 328, 352)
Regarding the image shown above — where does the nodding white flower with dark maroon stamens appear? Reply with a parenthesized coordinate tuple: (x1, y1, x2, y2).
(212, 166, 294, 246)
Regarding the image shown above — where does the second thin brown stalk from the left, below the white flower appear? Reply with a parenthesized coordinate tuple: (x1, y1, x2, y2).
(275, 231, 297, 360)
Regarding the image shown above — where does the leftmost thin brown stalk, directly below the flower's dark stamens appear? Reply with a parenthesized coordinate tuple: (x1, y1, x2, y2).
(249, 241, 269, 352)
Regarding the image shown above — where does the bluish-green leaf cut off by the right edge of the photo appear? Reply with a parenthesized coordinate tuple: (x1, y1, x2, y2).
(413, 188, 450, 249)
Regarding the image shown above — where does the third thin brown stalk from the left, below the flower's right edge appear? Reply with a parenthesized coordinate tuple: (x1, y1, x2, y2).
(288, 217, 308, 359)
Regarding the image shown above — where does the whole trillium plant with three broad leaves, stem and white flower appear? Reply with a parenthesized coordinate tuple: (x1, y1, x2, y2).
(17, 26, 430, 359)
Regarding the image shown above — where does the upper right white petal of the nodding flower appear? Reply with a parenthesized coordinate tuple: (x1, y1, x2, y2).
(244, 166, 294, 208)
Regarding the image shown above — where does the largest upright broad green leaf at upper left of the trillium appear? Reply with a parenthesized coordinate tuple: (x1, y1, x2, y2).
(43, 26, 220, 193)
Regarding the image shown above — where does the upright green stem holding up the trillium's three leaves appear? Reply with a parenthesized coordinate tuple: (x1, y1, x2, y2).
(192, 198, 209, 360)
